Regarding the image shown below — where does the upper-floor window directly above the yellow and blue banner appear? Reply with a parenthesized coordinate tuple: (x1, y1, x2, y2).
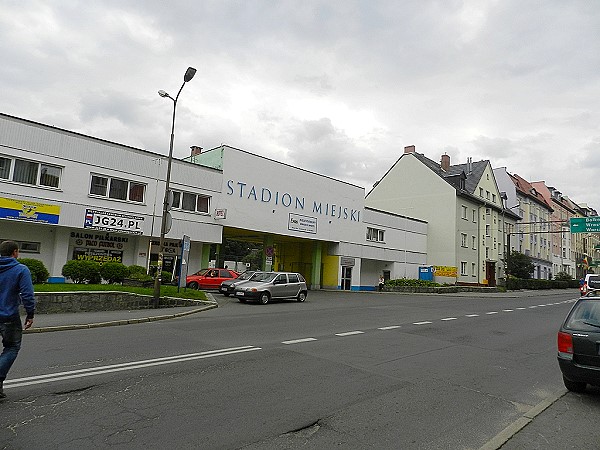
(0, 156, 62, 188)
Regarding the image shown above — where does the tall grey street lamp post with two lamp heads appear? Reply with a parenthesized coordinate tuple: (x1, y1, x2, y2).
(152, 67, 196, 308)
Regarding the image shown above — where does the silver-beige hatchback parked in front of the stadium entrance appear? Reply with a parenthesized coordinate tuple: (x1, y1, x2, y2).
(235, 272, 308, 305)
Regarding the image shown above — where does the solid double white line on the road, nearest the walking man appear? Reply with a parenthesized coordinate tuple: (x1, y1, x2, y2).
(4, 345, 262, 388)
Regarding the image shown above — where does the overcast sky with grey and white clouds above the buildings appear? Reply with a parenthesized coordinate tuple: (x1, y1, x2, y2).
(0, 0, 600, 210)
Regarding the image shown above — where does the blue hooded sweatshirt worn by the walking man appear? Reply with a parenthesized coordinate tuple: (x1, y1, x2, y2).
(0, 256, 35, 320)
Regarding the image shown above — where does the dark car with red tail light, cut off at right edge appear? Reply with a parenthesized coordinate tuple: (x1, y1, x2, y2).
(558, 297, 600, 392)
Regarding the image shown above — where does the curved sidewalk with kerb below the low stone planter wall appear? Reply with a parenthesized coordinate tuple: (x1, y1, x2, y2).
(24, 293, 219, 334)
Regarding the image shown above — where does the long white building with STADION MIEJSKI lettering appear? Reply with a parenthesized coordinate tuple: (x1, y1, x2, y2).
(0, 114, 427, 290)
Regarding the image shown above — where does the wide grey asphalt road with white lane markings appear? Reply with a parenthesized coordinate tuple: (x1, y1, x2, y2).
(0, 292, 598, 449)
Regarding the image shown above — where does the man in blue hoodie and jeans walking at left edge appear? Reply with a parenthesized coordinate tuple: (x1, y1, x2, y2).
(0, 241, 35, 399)
